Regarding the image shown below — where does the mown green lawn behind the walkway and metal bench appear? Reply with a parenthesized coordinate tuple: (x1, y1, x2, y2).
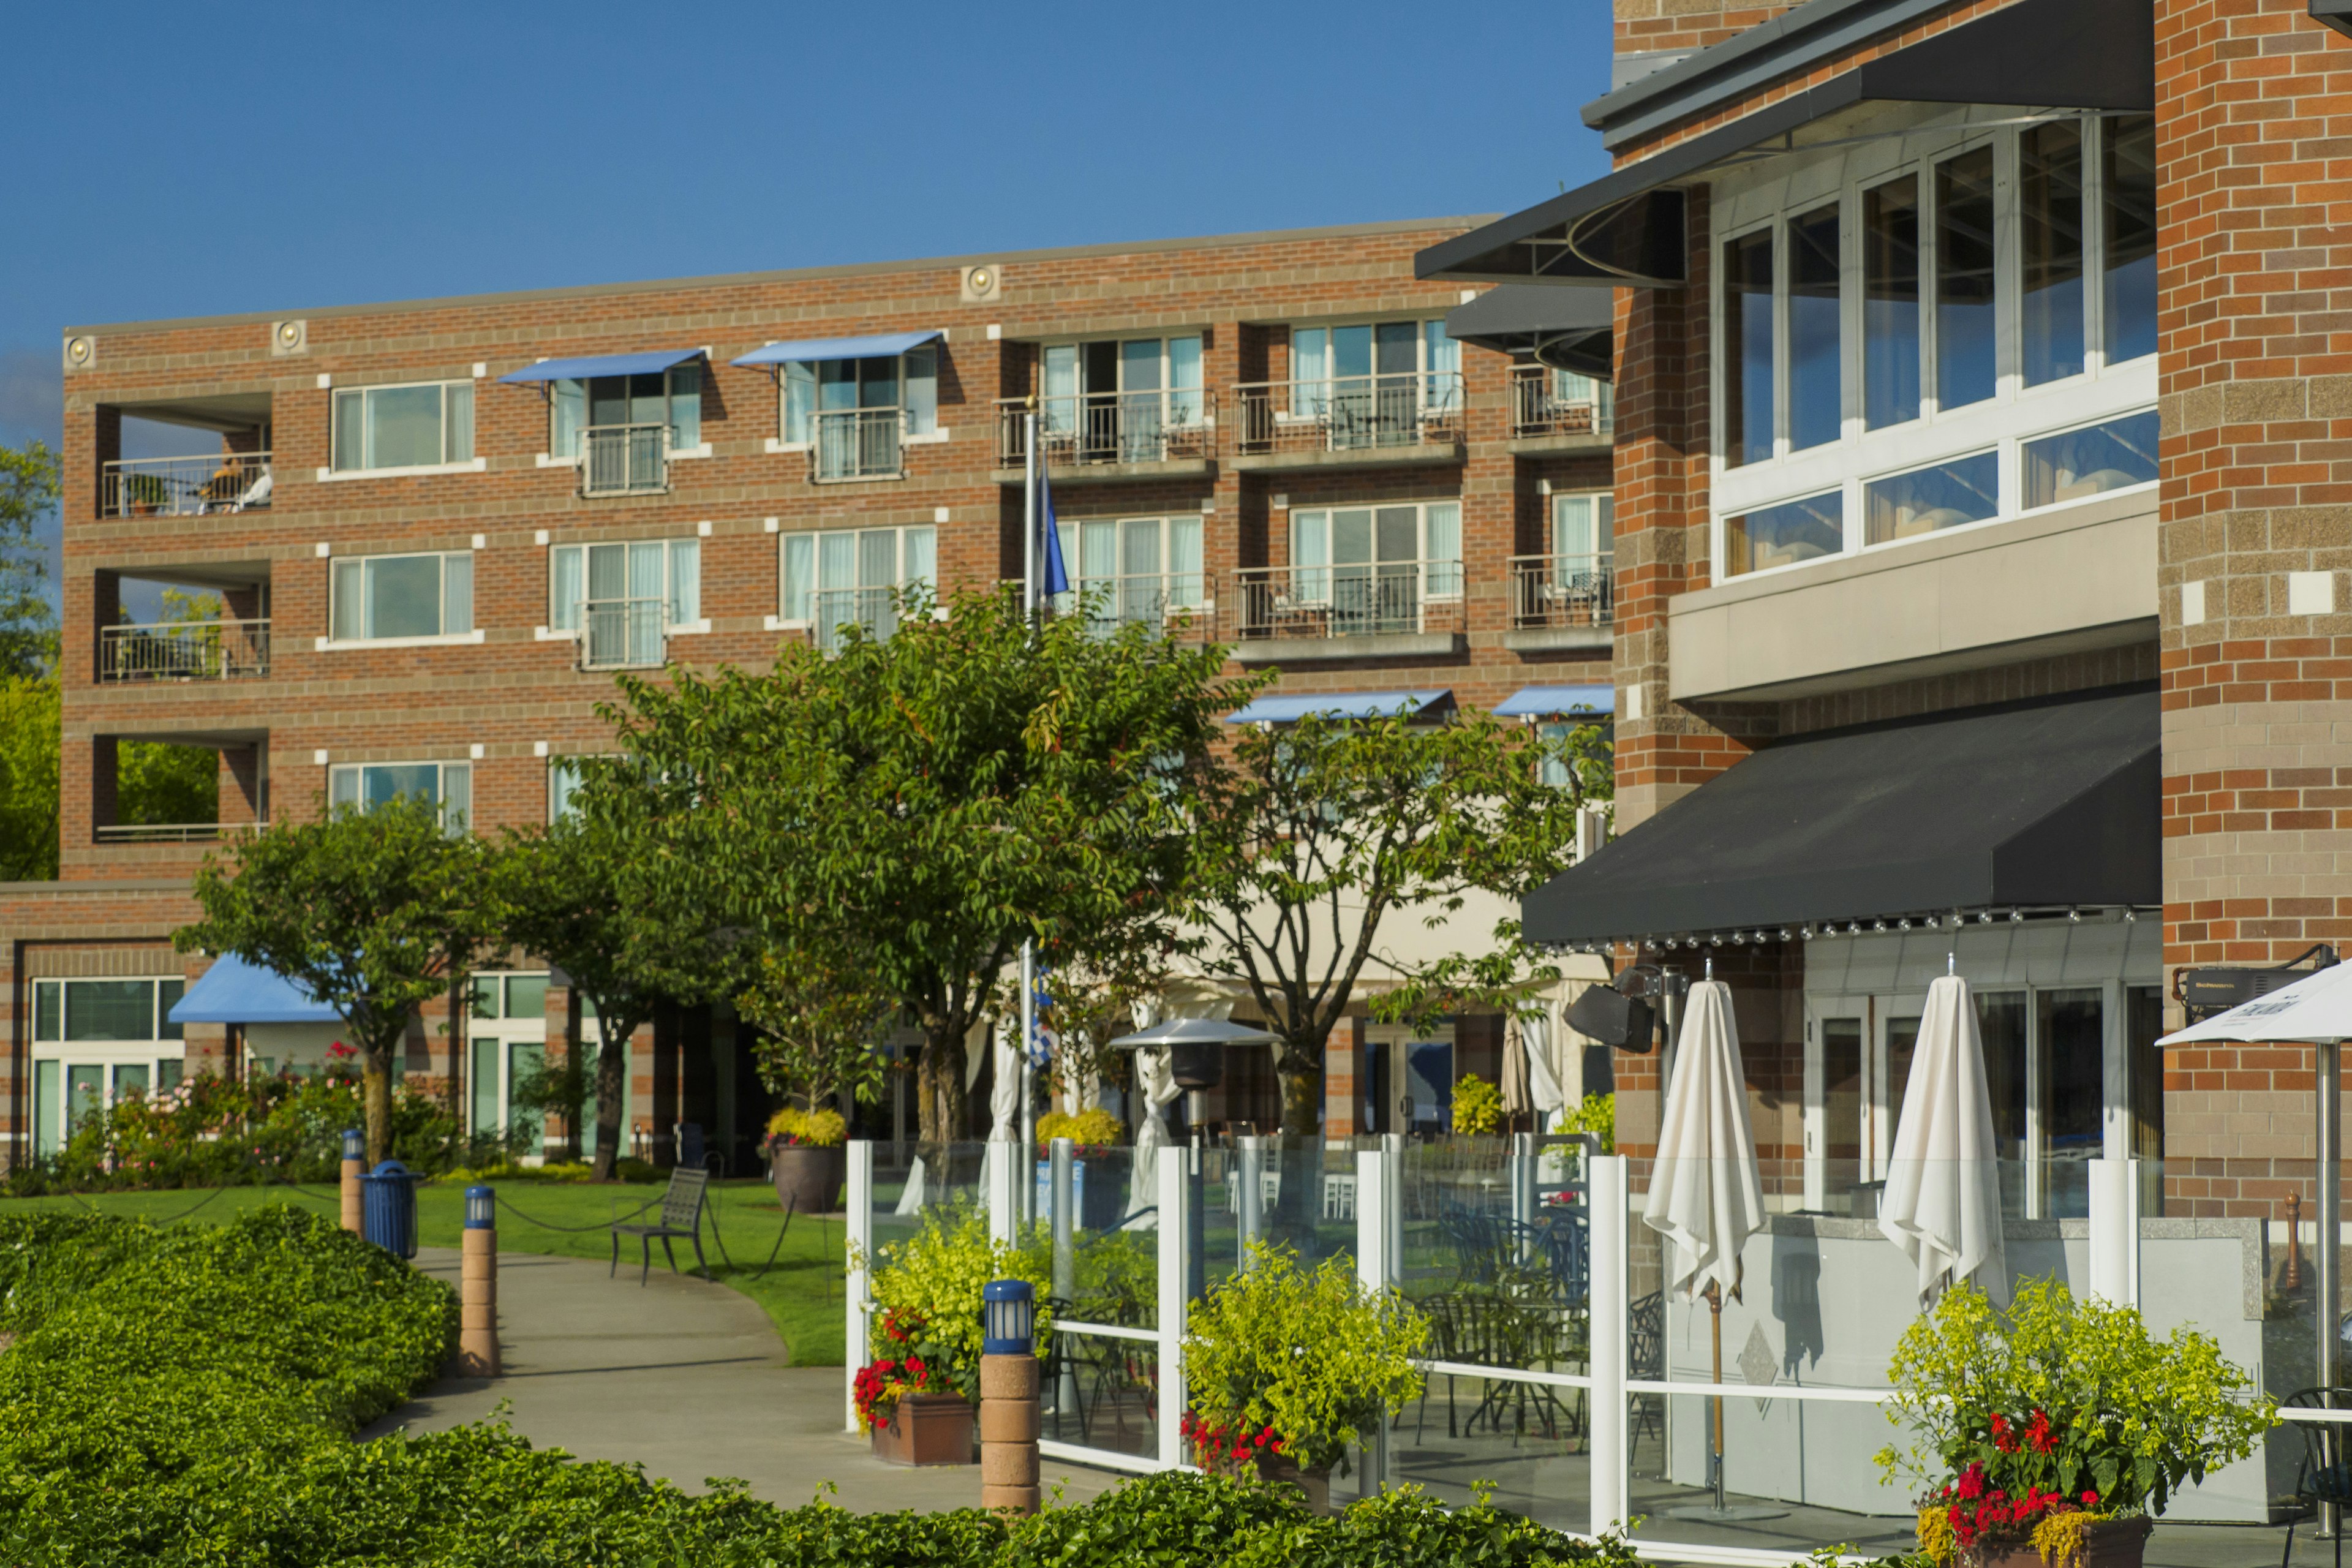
(0, 1180, 842, 1366)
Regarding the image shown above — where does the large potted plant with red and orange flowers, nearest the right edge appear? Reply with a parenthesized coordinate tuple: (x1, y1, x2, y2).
(1877, 1279, 2279, 1568)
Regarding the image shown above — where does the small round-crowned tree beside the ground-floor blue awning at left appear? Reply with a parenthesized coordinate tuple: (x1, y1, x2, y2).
(172, 797, 499, 1164)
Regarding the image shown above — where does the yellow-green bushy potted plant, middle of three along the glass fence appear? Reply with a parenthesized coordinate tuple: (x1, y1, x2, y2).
(1183, 1243, 1430, 1514)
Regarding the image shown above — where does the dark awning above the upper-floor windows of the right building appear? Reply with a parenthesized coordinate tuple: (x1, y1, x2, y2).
(1414, 0, 2157, 287)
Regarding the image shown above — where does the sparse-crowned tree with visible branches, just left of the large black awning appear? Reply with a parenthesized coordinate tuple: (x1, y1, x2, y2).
(1190, 710, 1593, 1136)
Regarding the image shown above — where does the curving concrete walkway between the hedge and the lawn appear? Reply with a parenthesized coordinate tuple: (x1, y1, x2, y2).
(362, 1248, 1120, 1512)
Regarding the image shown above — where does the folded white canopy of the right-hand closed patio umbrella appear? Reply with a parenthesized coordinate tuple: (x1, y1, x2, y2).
(1879, 976, 2008, 1307)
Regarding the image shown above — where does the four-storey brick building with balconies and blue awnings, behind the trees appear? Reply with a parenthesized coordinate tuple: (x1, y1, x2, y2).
(0, 219, 1609, 1175)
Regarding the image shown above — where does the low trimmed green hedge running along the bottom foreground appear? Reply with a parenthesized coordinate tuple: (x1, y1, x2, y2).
(0, 1208, 1632, 1568)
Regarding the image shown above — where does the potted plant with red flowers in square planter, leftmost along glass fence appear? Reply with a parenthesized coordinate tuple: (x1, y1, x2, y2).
(856, 1208, 1051, 1464)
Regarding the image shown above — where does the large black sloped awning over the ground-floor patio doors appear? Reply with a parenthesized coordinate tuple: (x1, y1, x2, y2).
(1524, 689, 2164, 943)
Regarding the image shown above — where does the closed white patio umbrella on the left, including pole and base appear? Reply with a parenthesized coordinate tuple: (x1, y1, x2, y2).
(1642, 966, 1781, 1518)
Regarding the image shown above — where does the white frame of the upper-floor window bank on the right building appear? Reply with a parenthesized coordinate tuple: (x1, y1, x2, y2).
(1708, 110, 2157, 583)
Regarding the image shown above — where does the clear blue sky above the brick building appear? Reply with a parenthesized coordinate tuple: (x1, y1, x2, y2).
(0, 0, 1609, 601)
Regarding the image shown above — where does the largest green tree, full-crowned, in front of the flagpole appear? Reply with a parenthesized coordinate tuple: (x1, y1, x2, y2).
(581, 592, 1230, 1140)
